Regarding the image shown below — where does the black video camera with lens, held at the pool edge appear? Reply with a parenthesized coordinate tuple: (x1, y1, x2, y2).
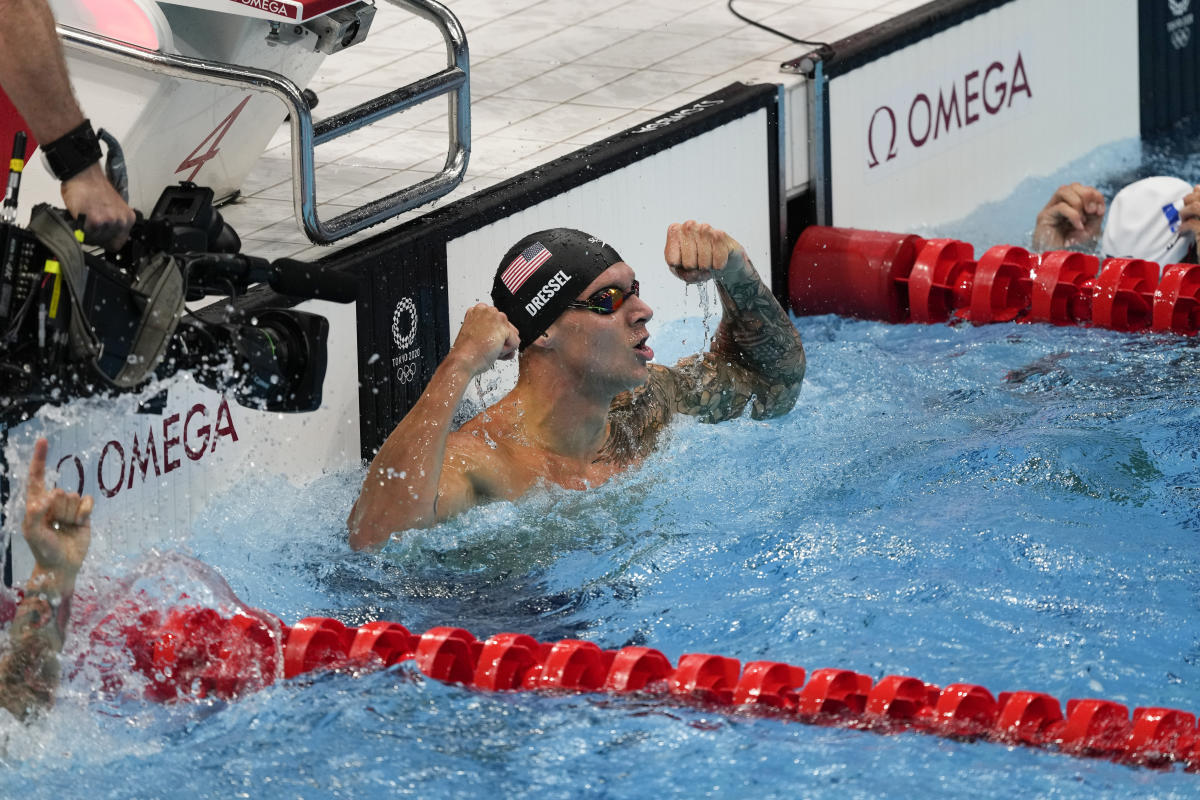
(0, 182, 329, 420)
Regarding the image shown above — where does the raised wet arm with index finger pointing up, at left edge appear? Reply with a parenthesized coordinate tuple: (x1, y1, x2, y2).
(0, 439, 92, 718)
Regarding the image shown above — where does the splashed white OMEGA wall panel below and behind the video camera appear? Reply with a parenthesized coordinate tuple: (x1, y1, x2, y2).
(0, 301, 360, 581)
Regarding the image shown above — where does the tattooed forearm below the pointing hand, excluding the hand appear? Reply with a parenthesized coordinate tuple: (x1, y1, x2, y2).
(0, 591, 71, 720)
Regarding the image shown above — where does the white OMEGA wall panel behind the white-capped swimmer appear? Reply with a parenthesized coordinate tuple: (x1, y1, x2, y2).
(816, 0, 1139, 231)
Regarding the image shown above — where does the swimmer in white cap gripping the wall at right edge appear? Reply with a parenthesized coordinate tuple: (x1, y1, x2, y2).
(1033, 175, 1200, 264)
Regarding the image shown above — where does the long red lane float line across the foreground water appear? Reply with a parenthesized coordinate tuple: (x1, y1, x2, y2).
(92, 609, 1200, 771)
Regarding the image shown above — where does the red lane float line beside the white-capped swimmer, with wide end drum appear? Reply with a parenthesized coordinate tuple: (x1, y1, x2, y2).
(788, 225, 1200, 336)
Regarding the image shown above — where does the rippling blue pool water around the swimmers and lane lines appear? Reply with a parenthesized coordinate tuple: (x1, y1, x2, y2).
(0, 131, 1200, 800)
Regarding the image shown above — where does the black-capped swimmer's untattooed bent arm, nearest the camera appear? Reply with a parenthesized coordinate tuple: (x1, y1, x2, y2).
(347, 303, 520, 549)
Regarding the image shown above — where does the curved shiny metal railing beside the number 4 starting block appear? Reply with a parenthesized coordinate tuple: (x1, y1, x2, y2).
(58, 0, 470, 245)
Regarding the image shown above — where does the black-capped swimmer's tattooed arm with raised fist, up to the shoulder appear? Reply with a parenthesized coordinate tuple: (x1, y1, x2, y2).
(604, 221, 805, 462)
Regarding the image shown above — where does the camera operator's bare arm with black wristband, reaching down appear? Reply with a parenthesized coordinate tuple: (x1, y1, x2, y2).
(0, 0, 134, 249)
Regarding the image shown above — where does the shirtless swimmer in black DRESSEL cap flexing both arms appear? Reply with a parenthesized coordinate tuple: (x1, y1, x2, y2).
(347, 222, 805, 549)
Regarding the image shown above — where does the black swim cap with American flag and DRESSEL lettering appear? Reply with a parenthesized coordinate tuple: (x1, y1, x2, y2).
(492, 228, 624, 350)
